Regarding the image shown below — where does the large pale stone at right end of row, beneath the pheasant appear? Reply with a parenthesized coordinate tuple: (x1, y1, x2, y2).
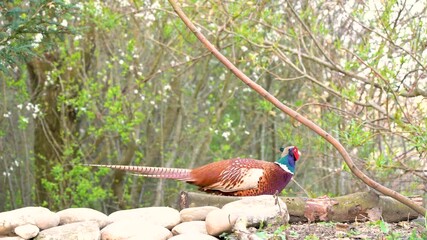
(222, 195, 289, 226)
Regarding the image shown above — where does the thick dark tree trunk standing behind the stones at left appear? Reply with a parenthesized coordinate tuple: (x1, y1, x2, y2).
(27, 54, 76, 208)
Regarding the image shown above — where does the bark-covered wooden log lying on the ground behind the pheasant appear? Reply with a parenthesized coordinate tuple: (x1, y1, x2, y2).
(178, 191, 422, 223)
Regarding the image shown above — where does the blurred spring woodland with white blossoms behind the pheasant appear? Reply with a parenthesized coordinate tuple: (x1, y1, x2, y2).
(0, 0, 427, 212)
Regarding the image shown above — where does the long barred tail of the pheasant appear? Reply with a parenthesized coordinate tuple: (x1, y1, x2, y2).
(87, 164, 191, 181)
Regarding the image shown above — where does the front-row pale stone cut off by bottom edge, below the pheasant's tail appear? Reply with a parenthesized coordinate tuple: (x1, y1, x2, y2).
(101, 219, 172, 240)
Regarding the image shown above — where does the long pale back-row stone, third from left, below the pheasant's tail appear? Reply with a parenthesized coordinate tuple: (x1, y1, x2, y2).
(108, 207, 181, 229)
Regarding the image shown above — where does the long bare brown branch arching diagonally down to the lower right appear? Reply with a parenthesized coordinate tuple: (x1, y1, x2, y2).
(169, 0, 427, 215)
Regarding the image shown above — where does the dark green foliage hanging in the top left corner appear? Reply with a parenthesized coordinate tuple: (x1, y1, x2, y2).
(0, 0, 75, 72)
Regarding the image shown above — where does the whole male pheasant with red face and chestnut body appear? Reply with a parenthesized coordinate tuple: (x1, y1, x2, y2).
(89, 146, 300, 196)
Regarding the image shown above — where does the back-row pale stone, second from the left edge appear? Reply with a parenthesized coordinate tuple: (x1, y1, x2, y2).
(57, 208, 110, 228)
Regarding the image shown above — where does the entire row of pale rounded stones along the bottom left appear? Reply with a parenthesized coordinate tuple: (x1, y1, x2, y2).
(0, 196, 289, 240)
